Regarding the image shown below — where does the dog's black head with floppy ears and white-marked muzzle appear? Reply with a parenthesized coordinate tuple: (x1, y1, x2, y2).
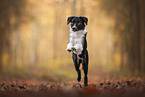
(67, 16, 88, 32)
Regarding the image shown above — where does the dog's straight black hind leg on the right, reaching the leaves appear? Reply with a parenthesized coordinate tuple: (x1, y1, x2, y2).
(82, 50, 88, 86)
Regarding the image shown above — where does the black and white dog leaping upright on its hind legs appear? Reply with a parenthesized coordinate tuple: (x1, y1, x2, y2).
(66, 16, 88, 86)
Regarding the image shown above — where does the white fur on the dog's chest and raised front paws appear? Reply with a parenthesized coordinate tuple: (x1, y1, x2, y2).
(66, 27, 87, 55)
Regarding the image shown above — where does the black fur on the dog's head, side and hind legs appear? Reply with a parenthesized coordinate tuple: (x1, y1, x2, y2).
(67, 16, 89, 86)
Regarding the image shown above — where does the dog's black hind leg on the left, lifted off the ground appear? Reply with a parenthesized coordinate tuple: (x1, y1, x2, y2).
(72, 53, 81, 82)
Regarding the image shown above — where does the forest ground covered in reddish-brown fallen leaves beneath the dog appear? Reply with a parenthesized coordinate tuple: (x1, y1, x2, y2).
(0, 78, 145, 97)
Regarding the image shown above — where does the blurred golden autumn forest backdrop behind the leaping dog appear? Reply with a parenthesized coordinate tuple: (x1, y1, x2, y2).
(0, 0, 145, 81)
